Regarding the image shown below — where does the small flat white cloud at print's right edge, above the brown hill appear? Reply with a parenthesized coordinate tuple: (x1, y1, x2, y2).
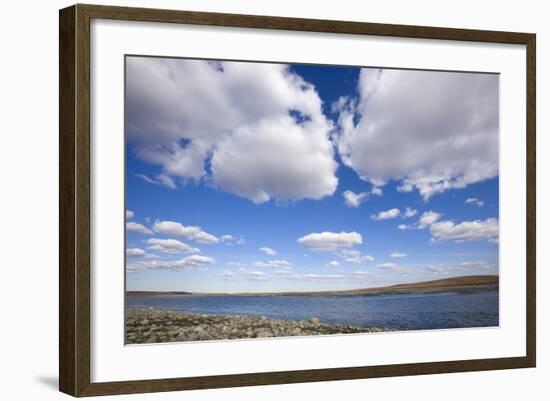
(430, 218, 499, 242)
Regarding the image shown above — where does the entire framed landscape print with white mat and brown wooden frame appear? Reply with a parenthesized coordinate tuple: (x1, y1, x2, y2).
(59, 5, 536, 396)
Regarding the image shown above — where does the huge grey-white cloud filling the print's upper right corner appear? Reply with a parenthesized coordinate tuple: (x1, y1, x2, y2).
(334, 68, 499, 200)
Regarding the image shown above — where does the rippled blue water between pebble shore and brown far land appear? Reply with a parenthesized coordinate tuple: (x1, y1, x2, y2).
(126, 288, 499, 330)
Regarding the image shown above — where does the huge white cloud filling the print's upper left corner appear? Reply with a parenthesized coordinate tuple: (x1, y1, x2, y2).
(126, 57, 338, 203)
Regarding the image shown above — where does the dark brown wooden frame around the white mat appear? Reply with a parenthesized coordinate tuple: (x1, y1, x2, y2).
(59, 4, 536, 396)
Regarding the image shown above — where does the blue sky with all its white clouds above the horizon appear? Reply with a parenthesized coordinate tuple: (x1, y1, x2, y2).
(125, 57, 499, 292)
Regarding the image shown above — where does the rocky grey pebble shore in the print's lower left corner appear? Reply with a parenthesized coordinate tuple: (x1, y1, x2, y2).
(126, 308, 390, 344)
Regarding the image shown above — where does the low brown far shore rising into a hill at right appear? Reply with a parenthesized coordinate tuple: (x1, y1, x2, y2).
(126, 275, 499, 297)
